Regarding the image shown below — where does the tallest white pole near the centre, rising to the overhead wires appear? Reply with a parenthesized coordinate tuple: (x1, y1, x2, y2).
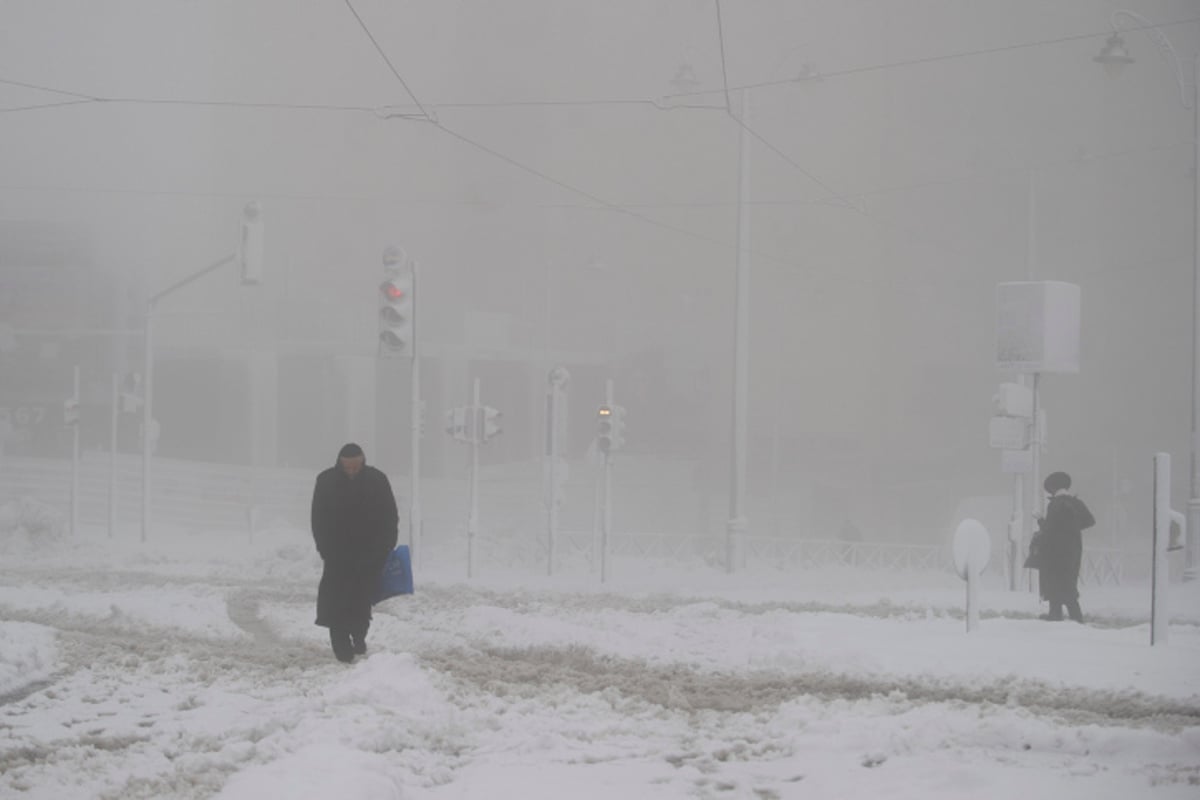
(725, 89, 750, 573)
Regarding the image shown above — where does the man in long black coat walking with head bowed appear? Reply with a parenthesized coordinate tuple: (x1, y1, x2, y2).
(312, 444, 400, 662)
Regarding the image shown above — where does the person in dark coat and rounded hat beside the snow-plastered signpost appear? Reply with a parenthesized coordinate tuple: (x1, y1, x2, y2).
(1038, 473, 1096, 622)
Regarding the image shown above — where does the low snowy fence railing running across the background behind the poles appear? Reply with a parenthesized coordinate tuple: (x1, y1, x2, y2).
(0, 453, 1132, 585)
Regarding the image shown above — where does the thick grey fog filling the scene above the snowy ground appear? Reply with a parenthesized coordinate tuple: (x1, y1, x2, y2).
(0, 0, 1200, 556)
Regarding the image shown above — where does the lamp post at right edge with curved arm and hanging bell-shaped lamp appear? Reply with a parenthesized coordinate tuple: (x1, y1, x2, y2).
(1092, 8, 1200, 581)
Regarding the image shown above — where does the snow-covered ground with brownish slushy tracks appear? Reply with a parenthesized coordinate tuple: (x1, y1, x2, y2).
(0, 515, 1200, 800)
